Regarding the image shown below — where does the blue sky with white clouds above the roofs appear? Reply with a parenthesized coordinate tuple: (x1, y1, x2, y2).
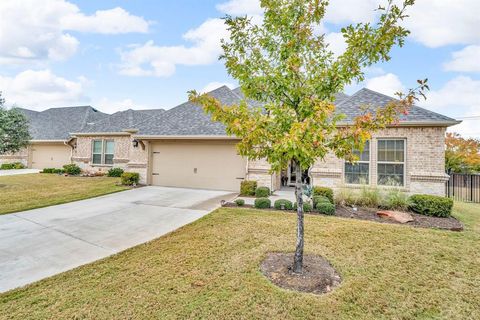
(0, 0, 480, 138)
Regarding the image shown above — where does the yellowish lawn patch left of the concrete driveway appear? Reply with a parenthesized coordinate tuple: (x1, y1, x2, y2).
(0, 174, 127, 215)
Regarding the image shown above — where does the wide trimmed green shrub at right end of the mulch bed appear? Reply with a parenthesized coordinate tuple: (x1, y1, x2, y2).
(410, 194, 453, 218)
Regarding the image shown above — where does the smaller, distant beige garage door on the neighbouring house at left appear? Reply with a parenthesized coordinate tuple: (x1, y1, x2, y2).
(31, 144, 71, 169)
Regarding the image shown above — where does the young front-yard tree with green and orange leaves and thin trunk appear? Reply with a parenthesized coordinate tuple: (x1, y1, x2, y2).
(190, 0, 428, 273)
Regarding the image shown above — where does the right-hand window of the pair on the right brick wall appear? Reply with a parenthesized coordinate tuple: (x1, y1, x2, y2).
(377, 139, 405, 186)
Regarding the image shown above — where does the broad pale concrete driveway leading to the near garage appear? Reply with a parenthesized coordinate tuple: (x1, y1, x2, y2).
(0, 187, 235, 292)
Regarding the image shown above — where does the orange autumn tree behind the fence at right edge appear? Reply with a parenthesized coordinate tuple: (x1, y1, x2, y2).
(445, 132, 480, 173)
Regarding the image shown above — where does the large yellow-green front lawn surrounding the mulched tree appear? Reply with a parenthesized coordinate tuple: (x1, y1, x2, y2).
(0, 204, 480, 319)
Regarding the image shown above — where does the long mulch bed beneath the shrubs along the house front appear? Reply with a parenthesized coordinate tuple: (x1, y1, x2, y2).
(224, 202, 463, 231)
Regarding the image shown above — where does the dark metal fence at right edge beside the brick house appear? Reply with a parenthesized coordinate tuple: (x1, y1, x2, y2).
(445, 173, 480, 203)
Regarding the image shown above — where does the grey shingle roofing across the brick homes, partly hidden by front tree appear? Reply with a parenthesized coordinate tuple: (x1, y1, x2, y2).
(15, 86, 459, 140)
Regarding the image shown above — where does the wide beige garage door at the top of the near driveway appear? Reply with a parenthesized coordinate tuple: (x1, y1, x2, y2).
(151, 141, 246, 191)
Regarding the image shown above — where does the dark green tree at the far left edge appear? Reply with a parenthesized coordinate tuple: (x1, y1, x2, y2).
(0, 92, 31, 154)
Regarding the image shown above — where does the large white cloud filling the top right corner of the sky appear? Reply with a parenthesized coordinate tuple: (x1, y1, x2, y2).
(405, 0, 480, 48)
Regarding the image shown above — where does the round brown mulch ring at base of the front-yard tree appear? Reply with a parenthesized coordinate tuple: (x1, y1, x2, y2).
(260, 253, 342, 294)
